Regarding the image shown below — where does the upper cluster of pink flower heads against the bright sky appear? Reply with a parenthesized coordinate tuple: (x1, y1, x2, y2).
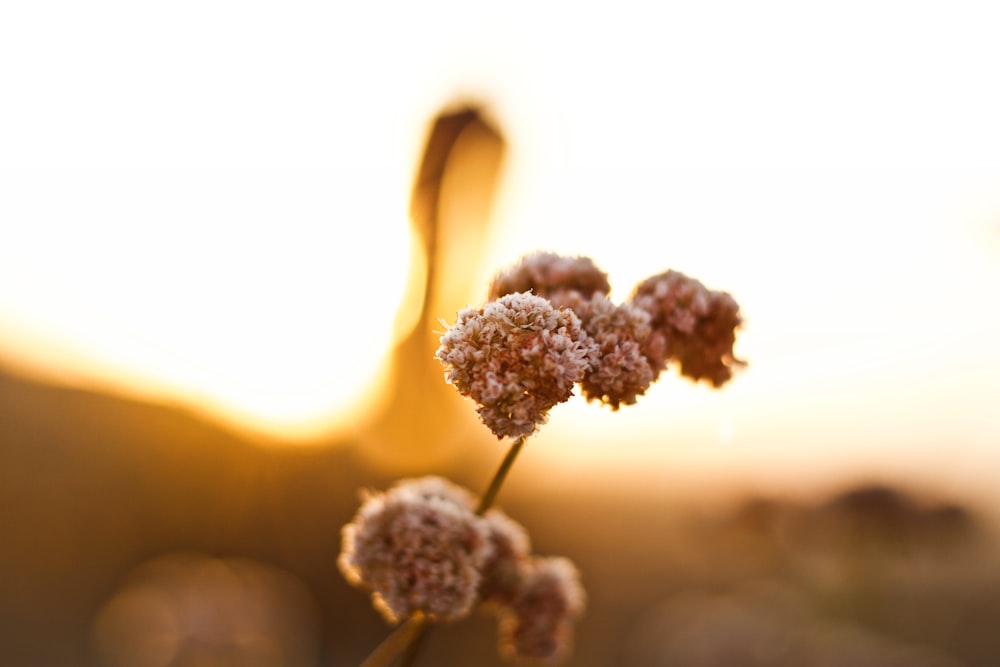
(437, 252, 743, 438)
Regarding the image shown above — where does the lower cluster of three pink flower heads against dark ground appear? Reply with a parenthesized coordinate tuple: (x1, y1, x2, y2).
(339, 476, 585, 660)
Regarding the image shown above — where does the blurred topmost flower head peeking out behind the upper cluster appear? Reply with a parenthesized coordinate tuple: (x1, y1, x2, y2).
(489, 252, 611, 299)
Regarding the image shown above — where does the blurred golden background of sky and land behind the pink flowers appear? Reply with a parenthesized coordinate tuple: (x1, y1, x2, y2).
(0, 0, 1000, 667)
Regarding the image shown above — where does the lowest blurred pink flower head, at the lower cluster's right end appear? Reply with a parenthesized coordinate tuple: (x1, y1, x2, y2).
(500, 558, 586, 662)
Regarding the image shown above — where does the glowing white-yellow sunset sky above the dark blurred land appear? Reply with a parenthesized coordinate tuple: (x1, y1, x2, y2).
(0, 0, 1000, 500)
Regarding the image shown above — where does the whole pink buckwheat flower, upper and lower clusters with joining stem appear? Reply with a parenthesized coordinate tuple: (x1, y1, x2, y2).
(338, 252, 743, 664)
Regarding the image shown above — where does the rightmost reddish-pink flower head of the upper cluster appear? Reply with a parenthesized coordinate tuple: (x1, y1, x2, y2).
(632, 271, 744, 387)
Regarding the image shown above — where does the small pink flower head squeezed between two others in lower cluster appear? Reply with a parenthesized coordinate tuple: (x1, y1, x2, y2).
(479, 509, 531, 605)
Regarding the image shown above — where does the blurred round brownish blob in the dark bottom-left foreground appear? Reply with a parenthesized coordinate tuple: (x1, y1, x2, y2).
(91, 552, 321, 667)
